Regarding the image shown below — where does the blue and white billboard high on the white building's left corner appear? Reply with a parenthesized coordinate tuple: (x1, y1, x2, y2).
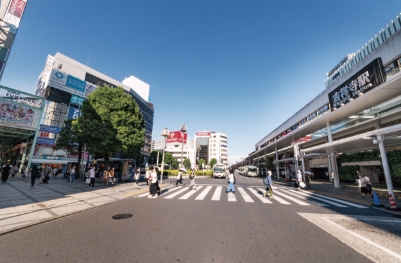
(49, 68, 86, 97)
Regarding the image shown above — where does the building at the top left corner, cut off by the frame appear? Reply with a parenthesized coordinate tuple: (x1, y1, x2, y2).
(0, 0, 28, 79)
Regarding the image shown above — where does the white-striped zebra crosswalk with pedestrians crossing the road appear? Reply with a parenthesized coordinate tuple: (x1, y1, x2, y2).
(135, 185, 367, 208)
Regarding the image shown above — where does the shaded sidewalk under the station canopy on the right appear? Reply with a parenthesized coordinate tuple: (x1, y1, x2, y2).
(275, 180, 401, 216)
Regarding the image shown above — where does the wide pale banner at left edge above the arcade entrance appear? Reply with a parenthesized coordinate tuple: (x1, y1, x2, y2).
(0, 102, 35, 127)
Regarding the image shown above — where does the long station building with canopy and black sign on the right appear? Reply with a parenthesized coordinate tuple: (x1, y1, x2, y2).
(236, 14, 401, 198)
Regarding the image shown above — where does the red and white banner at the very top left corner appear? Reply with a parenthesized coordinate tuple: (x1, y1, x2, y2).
(1, 0, 27, 34)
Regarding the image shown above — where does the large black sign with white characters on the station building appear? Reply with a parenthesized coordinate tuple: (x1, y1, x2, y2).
(329, 58, 386, 111)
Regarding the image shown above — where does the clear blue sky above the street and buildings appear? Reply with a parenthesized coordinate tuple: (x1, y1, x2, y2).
(1, 0, 401, 163)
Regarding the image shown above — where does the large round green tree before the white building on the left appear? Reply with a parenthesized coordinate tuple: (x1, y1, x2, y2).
(76, 86, 145, 165)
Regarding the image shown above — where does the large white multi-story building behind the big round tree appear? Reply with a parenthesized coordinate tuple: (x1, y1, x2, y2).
(35, 53, 154, 170)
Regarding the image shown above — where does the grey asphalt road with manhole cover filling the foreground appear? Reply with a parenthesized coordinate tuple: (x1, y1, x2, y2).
(0, 175, 401, 262)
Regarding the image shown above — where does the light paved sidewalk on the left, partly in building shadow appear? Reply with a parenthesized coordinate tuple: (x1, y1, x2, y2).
(0, 175, 153, 235)
